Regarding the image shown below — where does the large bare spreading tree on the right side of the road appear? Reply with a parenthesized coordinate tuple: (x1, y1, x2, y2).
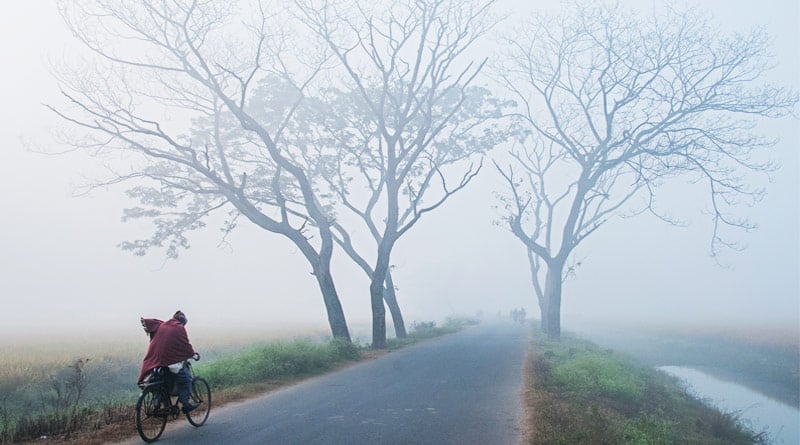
(496, 3, 797, 338)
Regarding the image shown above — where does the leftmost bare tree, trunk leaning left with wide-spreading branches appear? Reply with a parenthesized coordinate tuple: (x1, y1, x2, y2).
(51, 0, 350, 340)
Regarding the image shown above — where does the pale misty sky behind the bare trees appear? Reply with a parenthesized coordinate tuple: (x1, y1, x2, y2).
(0, 0, 800, 332)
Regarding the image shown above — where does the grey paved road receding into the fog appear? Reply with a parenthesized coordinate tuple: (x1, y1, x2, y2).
(122, 323, 527, 445)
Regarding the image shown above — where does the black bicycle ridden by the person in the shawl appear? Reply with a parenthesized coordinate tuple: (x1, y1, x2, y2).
(136, 356, 211, 442)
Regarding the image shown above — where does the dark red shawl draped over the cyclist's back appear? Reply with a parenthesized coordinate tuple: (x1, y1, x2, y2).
(137, 318, 194, 382)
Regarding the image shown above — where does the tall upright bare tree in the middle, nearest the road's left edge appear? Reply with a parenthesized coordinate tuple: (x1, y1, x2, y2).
(297, 0, 504, 348)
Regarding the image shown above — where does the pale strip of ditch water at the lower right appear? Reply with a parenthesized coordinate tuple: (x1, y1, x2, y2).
(658, 366, 800, 445)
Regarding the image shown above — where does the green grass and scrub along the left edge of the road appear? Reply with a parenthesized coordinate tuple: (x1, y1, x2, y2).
(0, 319, 477, 444)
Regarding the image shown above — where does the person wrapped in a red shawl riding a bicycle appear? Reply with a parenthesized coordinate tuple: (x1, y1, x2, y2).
(138, 311, 200, 413)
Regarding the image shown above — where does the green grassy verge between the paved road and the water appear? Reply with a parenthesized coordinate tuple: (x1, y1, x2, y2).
(526, 331, 768, 445)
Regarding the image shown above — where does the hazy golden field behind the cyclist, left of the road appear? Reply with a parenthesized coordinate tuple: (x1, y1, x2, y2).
(0, 320, 340, 443)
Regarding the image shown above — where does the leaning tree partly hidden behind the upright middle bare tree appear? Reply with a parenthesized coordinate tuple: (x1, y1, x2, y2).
(307, 87, 502, 338)
